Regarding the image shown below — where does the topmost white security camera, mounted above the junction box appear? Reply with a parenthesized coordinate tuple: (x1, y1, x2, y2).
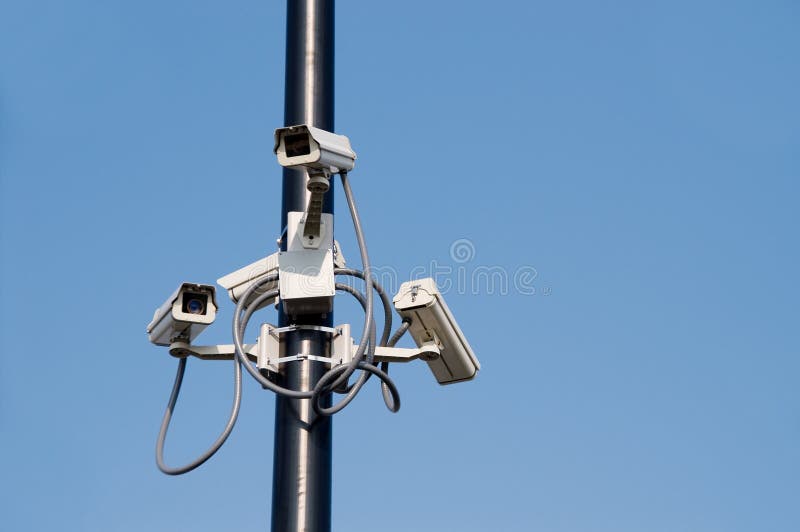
(275, 124, 356, 175)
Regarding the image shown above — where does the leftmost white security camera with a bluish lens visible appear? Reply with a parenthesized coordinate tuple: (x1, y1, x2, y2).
(147, 283, 217, 345)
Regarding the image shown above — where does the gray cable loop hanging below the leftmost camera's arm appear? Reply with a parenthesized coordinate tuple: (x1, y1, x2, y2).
(156, 358, 242, 475)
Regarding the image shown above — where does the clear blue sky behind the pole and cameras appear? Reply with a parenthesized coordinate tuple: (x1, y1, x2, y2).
(0, 0, 800, 532)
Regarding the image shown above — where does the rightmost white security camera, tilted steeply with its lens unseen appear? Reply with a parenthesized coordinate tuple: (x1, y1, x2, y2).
(392, 277, 481, 384)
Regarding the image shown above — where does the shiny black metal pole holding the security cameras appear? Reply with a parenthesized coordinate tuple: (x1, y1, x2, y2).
(272, 0, 334, 532)
